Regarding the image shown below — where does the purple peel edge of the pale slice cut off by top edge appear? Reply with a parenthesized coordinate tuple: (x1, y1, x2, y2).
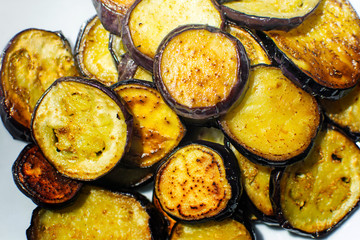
(215, 0, 320, 31)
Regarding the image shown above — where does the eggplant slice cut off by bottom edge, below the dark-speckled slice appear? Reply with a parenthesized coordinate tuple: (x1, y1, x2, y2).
(169, 218, 255, 240)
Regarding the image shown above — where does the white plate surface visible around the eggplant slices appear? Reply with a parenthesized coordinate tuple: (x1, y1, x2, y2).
(0, 0, 360, 240)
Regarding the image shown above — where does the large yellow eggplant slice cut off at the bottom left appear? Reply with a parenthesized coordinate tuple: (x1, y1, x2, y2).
(26, 186, 166, 240)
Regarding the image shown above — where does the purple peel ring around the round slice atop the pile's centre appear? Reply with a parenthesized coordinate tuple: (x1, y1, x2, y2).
(153, 24, 250, 122)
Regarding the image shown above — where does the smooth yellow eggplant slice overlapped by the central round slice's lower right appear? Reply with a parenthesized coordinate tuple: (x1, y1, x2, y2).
(219, 65, 322, 166)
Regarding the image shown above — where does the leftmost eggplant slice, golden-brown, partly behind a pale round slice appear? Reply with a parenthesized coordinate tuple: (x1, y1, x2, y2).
(0, 29, 79, 142)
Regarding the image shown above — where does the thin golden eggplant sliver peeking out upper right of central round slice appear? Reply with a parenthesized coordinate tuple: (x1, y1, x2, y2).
(226, 23, 272, 66)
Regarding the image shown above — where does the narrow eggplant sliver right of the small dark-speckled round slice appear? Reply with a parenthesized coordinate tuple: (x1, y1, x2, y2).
(227, 141, 277, 224)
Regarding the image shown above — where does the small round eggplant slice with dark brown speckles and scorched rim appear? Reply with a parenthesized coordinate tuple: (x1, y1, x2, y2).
(154, 141, 242, 222)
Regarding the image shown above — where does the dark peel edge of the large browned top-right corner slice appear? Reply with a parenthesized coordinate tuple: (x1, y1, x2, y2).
(256, 31, 355, 100)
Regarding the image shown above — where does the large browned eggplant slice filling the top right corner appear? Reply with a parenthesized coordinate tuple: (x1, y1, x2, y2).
(259, 0, 360, 100)
